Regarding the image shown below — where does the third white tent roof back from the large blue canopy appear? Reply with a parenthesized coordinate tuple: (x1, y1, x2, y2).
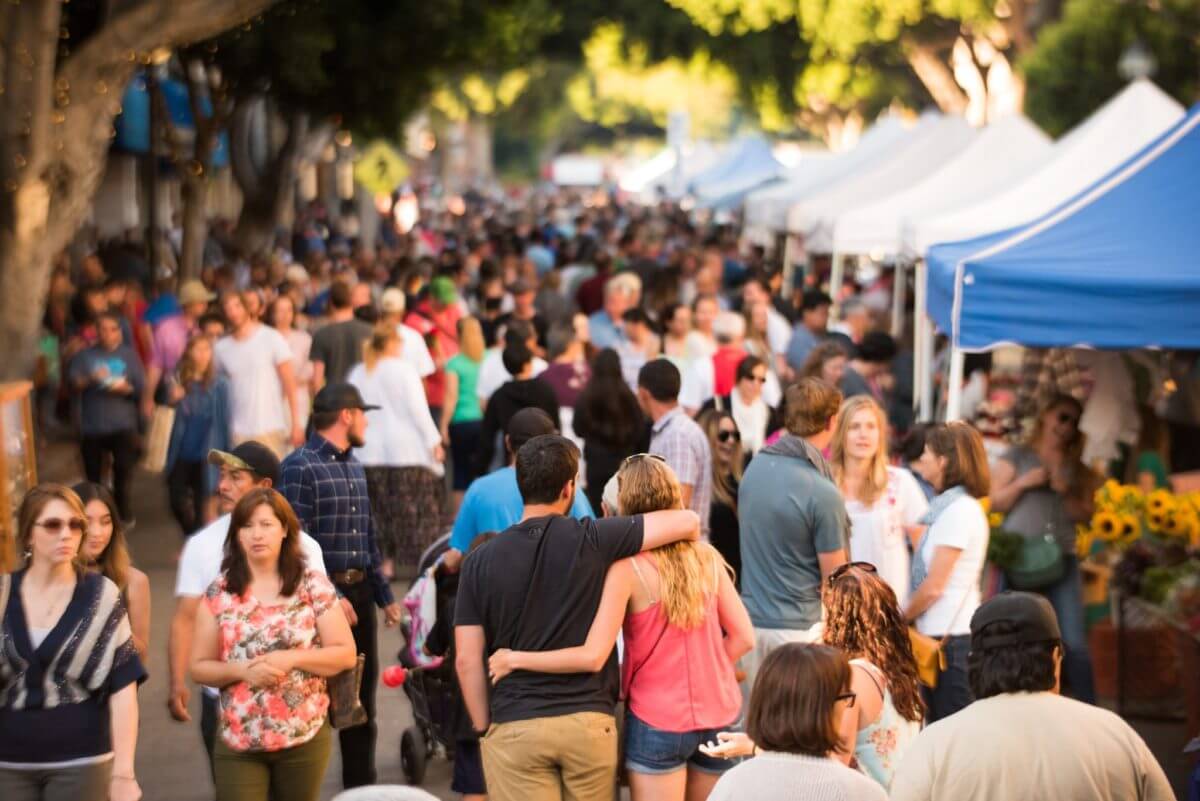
(787, 115, 977, 253)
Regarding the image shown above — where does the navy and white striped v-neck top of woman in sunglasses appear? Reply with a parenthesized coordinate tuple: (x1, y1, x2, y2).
(0, 571, 146, 765)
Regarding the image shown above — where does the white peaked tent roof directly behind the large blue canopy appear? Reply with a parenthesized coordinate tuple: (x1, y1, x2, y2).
(910, 80, 1183, 253)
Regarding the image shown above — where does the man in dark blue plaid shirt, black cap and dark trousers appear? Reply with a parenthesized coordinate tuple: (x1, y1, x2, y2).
(280, 384, 400, 788)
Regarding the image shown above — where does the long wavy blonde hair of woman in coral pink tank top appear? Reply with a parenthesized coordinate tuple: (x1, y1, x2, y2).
(617, 456, 730, 628)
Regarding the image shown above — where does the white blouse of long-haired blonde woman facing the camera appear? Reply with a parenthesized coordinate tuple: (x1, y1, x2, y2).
(846, 466, 929, 609)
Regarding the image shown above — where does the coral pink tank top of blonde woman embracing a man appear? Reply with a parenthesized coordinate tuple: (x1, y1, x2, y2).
(622, 555, 742, 731)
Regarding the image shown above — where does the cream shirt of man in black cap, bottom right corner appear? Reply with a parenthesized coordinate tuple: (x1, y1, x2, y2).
(892, 692, 1175, 801)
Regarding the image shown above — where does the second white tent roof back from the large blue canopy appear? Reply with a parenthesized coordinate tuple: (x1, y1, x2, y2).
(833, 114, 1052, 255)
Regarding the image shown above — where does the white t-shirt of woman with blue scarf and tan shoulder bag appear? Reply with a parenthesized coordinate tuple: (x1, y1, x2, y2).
(917, 495, 989, 637)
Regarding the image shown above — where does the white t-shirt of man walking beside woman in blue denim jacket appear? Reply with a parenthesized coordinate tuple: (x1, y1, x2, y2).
(212, 325, 292, 439)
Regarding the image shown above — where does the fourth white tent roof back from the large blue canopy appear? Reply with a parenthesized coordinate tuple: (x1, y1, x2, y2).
(744, 116, 912, 231)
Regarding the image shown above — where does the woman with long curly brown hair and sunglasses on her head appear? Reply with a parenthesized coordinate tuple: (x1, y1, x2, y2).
(700, 562, 925, 789)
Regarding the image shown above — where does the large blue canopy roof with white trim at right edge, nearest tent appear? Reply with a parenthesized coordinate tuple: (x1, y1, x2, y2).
(928, 104, 1200, 350)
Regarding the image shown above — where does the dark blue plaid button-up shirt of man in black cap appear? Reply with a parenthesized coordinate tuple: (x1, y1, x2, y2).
(280, 434, 394, 607)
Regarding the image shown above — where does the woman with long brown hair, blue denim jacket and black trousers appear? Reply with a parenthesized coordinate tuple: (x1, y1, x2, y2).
(166, 335, 232, 536)
